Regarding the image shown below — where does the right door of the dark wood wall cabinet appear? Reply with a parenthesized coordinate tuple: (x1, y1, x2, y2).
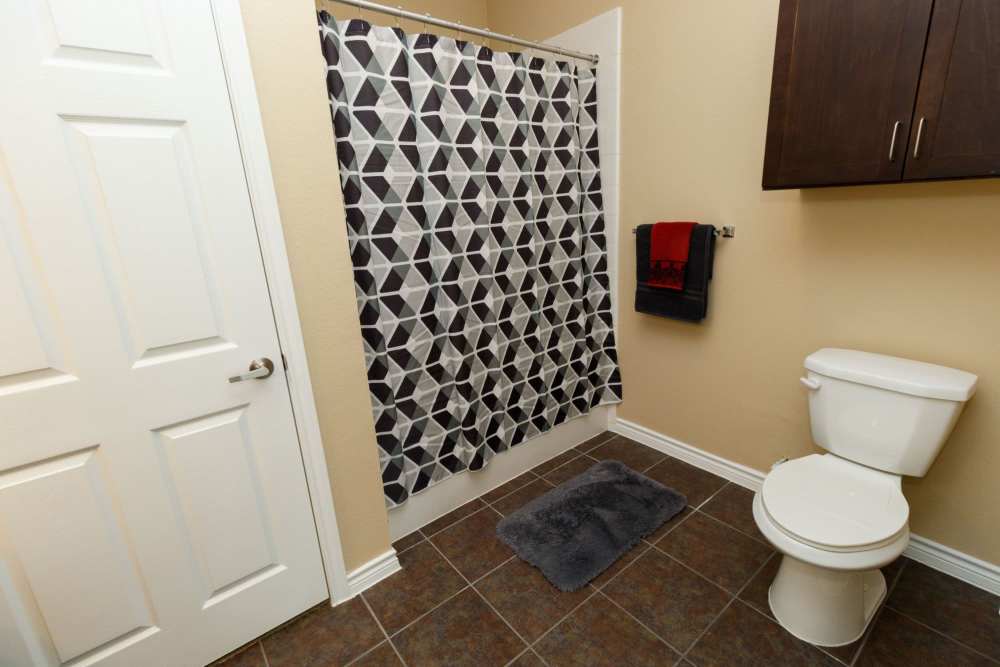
(905, 0, 1000, 179)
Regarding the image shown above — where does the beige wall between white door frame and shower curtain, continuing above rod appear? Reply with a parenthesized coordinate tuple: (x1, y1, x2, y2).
(242, 0, 486, 570)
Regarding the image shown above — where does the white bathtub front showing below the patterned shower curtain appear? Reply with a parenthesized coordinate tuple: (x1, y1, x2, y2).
(389, 406, 611, 542)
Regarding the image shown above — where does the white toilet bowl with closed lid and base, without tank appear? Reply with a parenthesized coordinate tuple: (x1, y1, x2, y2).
(753, 454, 910, 646)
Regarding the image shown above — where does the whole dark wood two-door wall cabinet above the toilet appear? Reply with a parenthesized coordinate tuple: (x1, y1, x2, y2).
(763, 0, 1000, 190)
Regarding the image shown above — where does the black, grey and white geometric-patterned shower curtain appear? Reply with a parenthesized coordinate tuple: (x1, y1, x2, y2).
(319, 11, 621, 506)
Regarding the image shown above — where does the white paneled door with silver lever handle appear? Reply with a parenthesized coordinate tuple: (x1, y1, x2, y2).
(0, 0, 326, 667)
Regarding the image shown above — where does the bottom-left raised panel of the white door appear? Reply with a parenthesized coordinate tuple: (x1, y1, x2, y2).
(0, 446, 159, 663)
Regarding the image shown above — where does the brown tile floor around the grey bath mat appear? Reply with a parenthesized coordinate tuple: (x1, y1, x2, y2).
(213, 434, 1000, 667)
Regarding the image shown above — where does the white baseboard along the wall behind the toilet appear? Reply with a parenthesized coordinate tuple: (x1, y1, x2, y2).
(609, 419, 1000, 595)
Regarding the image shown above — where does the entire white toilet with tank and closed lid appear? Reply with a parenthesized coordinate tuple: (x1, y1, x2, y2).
(753, 348, 977, 646)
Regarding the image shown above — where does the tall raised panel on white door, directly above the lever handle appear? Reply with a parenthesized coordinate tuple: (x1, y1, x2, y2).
(66, 118, 225, 365)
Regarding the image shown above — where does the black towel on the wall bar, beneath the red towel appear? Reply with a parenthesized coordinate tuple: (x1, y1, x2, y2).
(635, 225, 715, 322)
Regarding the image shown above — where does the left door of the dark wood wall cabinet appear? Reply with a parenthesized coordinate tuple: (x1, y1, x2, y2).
(763, 0, 936, 190)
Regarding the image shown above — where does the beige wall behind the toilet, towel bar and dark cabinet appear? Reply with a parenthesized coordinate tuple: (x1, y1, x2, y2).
(489, 0, 1000, 562)
